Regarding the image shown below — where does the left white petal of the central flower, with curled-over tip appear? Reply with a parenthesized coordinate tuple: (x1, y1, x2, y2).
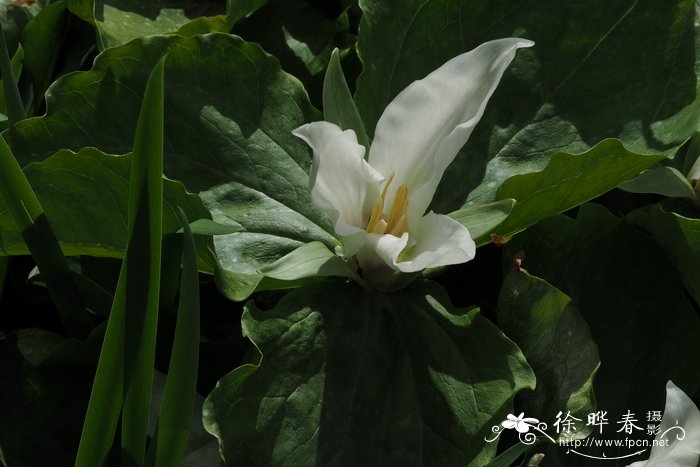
(292, 122, 383, 235)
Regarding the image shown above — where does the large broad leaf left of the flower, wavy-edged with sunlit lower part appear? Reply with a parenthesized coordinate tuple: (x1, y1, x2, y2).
(11, 34, 337, 299)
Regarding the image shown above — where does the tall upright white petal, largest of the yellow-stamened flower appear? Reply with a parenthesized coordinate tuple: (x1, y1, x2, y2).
(369, 38, 533, 222)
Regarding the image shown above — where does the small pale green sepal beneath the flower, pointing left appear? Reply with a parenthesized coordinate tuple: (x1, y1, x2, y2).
(260, 242, 362, 283)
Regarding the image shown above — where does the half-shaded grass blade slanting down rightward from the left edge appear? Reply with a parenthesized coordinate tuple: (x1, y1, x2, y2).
(0, 136, 92, 338)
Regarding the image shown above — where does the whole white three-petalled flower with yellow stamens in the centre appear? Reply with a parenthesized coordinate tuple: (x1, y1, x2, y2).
(294, 38, 533, 277)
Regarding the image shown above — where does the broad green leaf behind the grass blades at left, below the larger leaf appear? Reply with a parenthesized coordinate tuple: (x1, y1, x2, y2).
(0, 148, 214, 273)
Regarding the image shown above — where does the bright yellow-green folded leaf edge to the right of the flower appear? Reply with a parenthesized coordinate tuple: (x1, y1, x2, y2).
(496, 140, 664, 236)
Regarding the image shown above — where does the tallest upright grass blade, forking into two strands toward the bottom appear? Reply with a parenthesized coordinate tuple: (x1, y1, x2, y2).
(75, 59, 165, 467)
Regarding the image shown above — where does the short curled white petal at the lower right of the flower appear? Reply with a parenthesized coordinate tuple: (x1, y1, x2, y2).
(394, 211, 476, 272)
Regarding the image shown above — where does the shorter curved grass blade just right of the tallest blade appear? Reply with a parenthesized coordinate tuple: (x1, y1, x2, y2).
(148, 210, 199, 467)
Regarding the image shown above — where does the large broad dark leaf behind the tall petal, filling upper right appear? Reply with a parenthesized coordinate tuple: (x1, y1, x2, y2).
(355, 0, 700, 212)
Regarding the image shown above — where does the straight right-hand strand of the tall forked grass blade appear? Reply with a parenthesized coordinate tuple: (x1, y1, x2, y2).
(122, 57, 165, 466)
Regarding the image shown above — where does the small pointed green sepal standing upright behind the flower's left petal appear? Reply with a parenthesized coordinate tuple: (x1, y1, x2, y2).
(323, 49, 369, 151)
